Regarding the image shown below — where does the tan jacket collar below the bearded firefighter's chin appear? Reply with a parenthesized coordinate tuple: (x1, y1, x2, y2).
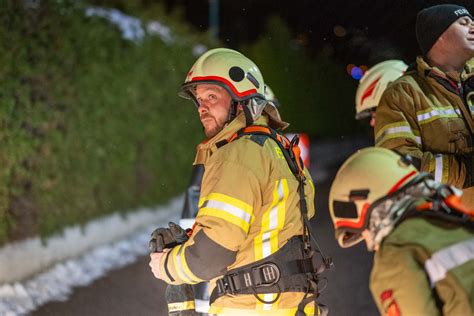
(193, 112, 268, 165)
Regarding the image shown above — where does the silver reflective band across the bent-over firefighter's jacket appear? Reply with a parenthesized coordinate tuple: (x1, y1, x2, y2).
(425, 238, 474, 287)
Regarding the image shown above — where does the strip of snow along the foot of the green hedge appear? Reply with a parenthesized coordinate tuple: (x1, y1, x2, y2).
(0, 197, 183, 316)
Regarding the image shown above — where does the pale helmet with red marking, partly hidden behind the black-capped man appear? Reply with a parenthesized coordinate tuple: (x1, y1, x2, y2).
(355, 60, 408, 120)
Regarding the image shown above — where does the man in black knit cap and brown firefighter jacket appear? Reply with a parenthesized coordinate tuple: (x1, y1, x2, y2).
(375, 4, 474, 208)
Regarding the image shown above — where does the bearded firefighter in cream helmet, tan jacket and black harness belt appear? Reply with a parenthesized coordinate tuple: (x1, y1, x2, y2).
(150, 48, 328, 315)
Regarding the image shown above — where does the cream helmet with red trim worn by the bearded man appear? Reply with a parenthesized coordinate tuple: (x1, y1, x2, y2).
(179, 48, 267, 121)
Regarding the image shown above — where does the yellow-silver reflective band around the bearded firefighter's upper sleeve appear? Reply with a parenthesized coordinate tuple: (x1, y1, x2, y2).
(197, 193, 253, 233)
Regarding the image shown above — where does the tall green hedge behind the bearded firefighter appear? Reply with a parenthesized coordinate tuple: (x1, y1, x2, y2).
(0, 1, 204, 244)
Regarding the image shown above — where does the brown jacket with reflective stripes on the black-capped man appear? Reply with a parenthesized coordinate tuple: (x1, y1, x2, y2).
(375, 57, 474, 207)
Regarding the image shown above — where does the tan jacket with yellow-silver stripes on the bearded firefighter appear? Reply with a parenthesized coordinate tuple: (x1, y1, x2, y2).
(157, 114, 314, 315)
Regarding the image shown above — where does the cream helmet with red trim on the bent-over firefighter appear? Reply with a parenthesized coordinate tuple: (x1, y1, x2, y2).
(329, 147, 419, 248)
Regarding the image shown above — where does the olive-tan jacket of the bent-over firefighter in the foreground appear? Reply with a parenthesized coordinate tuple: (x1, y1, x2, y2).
(370, 217, 474, 316)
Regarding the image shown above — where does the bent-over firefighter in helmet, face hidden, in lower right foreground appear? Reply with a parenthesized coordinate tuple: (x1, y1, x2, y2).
(329, 147, 474, 316)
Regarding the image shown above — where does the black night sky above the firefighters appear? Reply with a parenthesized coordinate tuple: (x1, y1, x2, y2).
(161, 0, 474, 66)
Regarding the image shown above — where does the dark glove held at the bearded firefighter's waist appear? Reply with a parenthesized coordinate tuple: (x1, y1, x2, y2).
(148, 222, 190, 252)
